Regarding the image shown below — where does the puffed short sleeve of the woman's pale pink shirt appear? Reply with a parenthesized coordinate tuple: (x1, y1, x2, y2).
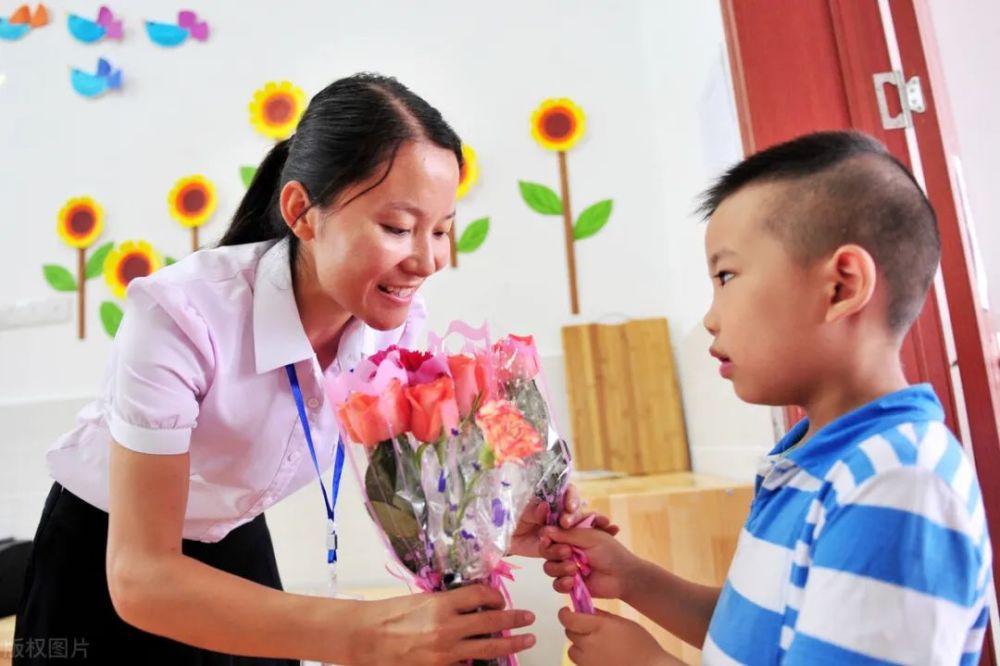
(110, 279, 212, 455)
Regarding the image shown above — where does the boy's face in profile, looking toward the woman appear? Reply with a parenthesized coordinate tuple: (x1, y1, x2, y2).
(704, 183, 830, 405)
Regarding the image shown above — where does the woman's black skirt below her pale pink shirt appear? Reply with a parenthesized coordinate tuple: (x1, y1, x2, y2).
(13, 483, 299, 666)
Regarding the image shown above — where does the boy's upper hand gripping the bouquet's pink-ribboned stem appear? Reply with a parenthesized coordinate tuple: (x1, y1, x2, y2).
(541, 527, 642, 599)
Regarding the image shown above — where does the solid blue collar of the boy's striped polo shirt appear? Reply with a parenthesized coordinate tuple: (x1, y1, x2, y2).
(768, 384, 944, 479)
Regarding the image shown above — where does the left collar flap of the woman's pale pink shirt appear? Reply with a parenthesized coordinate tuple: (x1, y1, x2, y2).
(253, 239, 315, 374)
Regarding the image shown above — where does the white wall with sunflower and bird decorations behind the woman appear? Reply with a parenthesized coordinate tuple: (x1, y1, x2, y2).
(0, 0, 773, 666)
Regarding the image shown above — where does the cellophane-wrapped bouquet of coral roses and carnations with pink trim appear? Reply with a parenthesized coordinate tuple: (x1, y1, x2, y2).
(327, 322, 589, 666)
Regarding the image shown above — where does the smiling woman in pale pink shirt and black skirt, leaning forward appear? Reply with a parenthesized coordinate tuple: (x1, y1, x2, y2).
(15, 75, 592, 665)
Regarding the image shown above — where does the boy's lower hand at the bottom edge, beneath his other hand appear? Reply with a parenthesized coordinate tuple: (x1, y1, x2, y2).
(559, 608, 682, 666)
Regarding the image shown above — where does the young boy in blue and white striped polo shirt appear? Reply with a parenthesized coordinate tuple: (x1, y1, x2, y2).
(542, 132, 992, 666)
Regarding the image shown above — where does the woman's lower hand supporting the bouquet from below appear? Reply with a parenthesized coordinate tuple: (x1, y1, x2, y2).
(350, 585, 535, 666)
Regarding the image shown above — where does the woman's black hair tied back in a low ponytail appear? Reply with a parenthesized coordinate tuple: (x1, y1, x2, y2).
(219, 73, 463, 255)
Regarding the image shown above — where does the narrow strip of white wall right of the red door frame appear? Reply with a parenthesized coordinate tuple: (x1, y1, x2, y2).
(928, 0, 1000, 329)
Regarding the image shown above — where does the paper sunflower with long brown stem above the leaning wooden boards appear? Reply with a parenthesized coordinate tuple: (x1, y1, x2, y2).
(519, 98, 613, 314)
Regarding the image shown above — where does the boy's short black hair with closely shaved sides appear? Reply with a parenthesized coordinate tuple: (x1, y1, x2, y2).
(699, 132, 941, 334)
